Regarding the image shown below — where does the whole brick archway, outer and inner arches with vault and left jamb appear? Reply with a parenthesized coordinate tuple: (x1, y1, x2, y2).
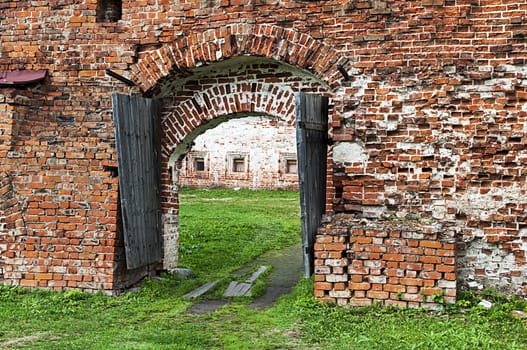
(122, 24, 347, 282)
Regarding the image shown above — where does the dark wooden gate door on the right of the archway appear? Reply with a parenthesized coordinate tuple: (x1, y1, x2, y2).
(295, 92, 328, 277)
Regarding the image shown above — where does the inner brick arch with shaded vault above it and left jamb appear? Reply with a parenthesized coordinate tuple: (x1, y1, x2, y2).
(156, 56, 327, 269)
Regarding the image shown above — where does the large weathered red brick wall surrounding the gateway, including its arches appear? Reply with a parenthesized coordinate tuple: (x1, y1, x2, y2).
(0, 0, 527, 306)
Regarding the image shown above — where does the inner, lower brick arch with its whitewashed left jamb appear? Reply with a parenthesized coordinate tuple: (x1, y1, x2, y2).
(157, 69, 327, 269)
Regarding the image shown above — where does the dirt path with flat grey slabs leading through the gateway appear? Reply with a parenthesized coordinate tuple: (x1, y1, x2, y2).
(185, 243, 303, 314)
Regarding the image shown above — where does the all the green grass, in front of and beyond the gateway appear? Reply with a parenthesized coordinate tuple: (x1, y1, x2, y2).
(0, 190, 527, 350)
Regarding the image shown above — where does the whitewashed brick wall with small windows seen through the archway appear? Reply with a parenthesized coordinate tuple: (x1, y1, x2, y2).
(178, 116, 298, 190)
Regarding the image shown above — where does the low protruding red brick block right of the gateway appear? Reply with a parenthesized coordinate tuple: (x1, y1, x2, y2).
(315, 214, 457, 307)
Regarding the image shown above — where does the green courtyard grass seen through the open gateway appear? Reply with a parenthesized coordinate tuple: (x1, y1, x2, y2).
(179, 189, 301, 276)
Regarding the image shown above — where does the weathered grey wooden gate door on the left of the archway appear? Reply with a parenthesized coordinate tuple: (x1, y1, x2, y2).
(112, 94, 163, 269)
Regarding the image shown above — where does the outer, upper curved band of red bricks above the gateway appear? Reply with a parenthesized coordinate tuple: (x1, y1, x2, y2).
(131, 23, 347, 92)
